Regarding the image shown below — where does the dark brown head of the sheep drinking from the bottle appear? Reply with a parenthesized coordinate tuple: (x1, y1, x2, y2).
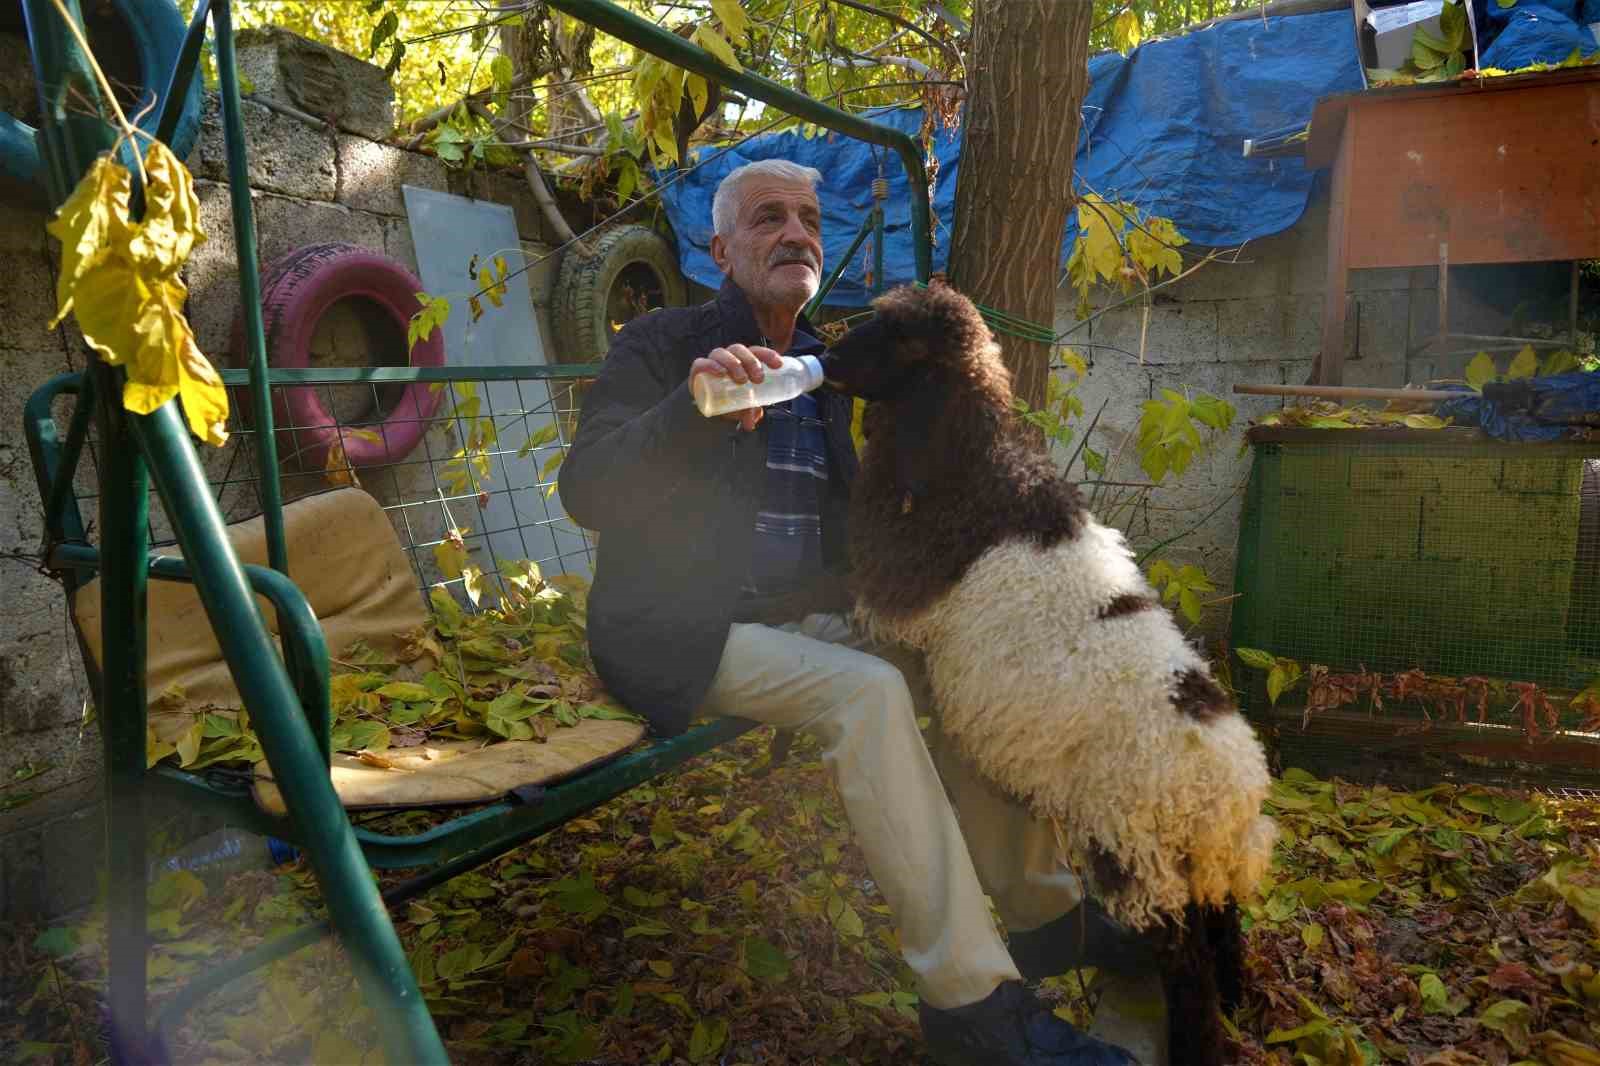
(822, 282, 1011, 403)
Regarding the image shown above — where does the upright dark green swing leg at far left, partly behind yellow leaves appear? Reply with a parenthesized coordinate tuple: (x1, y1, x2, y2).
(22, 0, 150, 1061)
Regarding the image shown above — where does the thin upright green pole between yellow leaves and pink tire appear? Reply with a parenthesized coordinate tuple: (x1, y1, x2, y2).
(211, 0, 290, 573)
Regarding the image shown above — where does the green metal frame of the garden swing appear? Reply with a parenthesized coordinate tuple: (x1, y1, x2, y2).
(22, 0, 931, 1063)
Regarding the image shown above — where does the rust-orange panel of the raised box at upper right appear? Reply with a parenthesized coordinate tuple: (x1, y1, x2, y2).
(1310, 69, 1600, 269)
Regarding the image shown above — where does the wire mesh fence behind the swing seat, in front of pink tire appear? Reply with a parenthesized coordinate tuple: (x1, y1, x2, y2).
(56, 367, 595, 611)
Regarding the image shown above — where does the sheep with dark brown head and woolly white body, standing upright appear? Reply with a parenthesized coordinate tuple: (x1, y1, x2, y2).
(822, 282, 1277, 1063)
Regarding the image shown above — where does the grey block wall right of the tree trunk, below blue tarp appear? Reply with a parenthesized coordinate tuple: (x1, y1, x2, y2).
(1056, 186, 1568, 635)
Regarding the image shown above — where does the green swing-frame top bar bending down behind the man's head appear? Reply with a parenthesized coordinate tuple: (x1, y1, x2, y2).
(549, 0, 933, 282)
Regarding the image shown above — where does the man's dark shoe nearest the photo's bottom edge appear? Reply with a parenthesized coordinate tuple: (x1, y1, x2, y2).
(922, 981, 1136, 1066)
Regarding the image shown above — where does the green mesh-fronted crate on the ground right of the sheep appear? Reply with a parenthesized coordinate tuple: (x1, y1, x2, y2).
(1230, 427, 1600, 784)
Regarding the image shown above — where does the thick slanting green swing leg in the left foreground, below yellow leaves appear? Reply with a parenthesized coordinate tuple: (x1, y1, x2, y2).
(130, 403, 450, 1063)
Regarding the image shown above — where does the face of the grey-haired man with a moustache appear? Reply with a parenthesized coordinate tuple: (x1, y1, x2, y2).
(710, 178, 822, 311)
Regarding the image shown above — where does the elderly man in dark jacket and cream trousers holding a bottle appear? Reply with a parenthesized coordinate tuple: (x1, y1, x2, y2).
(560, 160, 1139, 1066)
